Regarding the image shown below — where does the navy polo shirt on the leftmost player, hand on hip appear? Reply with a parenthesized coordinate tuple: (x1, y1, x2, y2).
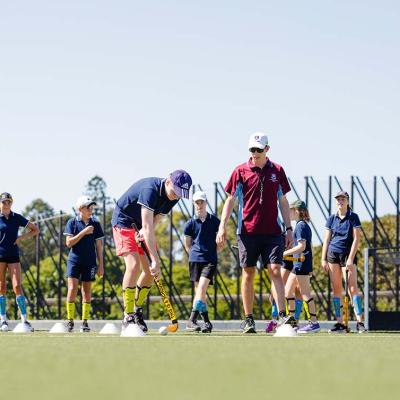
(0, 212, 29, 258)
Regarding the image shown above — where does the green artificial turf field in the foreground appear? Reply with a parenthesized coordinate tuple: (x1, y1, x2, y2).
(0, 332, 400, 400)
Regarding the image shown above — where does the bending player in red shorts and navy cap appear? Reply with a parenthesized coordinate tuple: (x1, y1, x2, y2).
(111, 170, 192, 332)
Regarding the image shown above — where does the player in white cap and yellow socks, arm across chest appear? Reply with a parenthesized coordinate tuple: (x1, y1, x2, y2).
(64, 196, 104, 332)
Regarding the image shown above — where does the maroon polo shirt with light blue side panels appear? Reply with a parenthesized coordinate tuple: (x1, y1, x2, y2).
(225, 159, 290, 235)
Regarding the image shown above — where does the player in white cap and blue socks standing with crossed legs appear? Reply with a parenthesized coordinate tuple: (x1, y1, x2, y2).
(184, 191, 220, 333)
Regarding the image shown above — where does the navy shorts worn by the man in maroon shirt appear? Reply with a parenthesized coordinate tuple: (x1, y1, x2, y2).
(237, 235, 285, 267)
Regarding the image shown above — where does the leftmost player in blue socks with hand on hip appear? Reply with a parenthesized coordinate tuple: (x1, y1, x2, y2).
(0, 192, 39, 332)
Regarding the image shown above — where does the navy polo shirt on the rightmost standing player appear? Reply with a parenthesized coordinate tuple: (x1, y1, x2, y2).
(325, 211, 361, 253)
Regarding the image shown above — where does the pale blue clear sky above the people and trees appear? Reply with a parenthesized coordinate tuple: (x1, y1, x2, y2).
(0, 0, 400, 219)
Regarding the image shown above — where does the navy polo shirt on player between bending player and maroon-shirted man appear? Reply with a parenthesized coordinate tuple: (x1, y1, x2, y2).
(184, 213, 220, 264)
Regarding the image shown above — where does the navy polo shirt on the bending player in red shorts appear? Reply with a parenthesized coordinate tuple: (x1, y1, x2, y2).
(111, 178, 179, 229)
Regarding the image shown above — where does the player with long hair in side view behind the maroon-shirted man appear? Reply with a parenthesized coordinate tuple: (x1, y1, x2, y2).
(283, 200, 321, 333)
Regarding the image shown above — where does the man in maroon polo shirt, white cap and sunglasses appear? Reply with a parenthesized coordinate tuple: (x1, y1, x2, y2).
(217, 133, 293, 333)
